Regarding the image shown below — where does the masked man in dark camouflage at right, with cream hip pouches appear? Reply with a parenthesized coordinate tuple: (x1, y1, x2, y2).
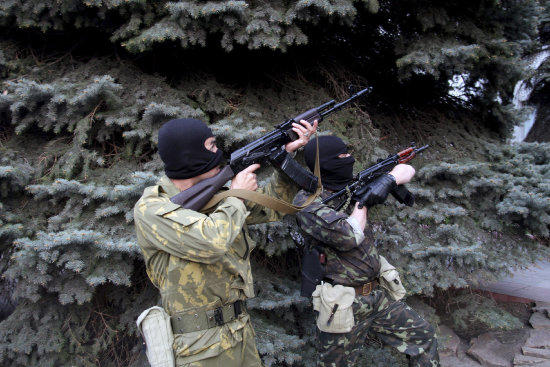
(294, 136, 439, 367)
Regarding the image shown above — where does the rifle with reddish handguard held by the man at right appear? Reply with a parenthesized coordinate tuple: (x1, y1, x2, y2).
(323, 142, 429, 210)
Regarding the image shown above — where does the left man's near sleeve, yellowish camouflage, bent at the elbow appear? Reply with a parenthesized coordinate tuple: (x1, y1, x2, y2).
(135, 197, 248, 264)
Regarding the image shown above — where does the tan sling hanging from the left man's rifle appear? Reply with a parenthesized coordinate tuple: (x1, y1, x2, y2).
(201, 134, 323, 214)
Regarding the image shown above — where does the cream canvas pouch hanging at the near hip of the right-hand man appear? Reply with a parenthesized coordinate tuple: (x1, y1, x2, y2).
(312, 282, 355, 334)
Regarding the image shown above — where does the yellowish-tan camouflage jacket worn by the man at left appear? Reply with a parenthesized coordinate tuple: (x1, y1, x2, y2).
(134, 174, 296, 364)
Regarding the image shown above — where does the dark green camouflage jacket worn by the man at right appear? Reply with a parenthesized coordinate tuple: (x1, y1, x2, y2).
(294, 190, 380, 286)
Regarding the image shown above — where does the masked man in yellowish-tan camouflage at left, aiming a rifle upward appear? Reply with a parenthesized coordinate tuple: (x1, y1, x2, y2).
(134, 119, 317, 367)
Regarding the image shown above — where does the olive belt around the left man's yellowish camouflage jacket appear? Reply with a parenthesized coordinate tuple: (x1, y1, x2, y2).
(170, 301, 246, 334)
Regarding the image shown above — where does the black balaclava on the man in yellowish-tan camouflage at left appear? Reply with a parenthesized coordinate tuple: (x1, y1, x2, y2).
(158, 119, 223, 179)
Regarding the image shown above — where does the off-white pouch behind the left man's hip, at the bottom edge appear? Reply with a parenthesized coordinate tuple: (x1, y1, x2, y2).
(136, 306, 176, 367)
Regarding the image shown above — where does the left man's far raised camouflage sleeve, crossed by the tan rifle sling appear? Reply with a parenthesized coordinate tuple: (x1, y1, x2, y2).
(246, 169, 298, 224)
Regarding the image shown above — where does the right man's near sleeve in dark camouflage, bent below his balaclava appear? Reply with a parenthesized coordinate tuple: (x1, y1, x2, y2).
(294, 190, 359, 251)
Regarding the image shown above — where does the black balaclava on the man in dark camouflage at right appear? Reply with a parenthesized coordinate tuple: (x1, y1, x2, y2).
(304, 135, 355, 190)
